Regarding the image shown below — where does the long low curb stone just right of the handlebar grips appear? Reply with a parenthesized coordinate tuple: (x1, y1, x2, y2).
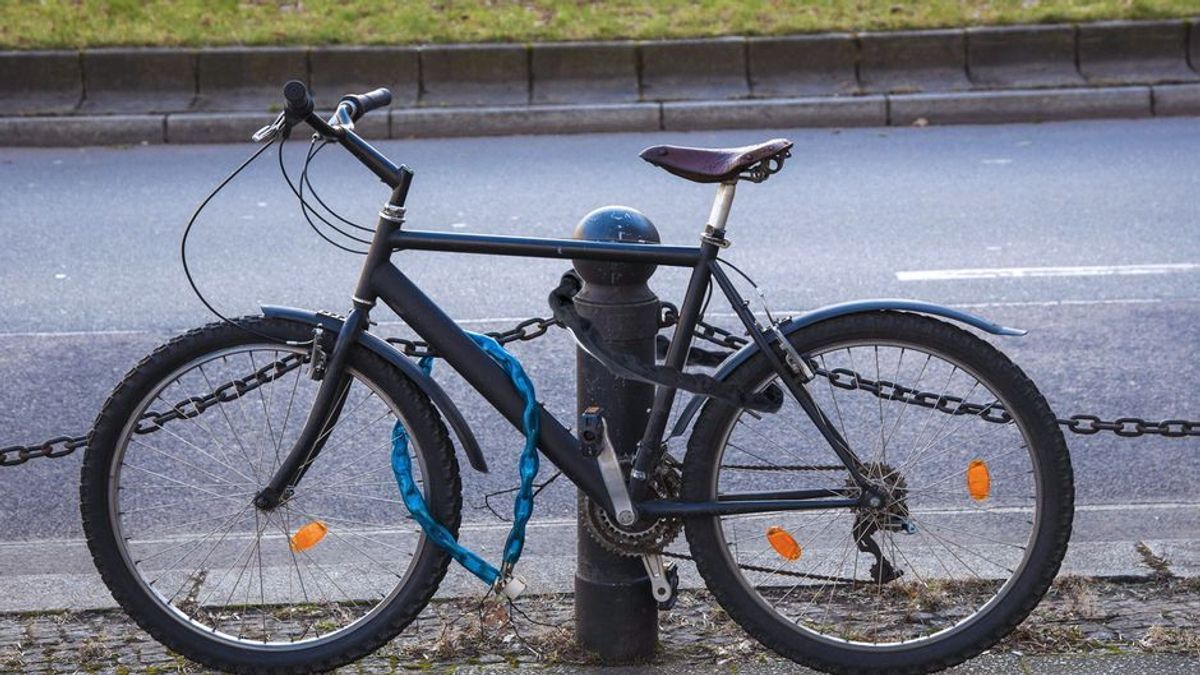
(391, 103, 659, 138)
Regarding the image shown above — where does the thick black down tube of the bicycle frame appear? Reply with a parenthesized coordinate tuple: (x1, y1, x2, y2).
(371, 264, 608, 504)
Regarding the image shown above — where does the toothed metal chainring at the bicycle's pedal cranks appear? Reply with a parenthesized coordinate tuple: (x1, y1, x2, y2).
(578, 456, 683, 556)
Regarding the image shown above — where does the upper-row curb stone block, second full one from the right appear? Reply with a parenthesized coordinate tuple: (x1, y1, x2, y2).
(967, 25, 1084, 88)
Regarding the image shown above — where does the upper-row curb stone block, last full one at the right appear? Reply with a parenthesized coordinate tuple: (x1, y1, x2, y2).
(1079, 22, 1200, 84)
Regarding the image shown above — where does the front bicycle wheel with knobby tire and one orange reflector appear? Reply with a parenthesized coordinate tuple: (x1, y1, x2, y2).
(80, 318, 461, 673)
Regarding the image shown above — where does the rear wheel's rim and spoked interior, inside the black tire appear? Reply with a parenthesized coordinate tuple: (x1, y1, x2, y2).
(712, 339, 1044, 651)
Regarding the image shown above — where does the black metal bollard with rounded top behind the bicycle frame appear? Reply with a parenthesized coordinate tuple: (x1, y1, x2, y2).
(574, 207, 659, 663)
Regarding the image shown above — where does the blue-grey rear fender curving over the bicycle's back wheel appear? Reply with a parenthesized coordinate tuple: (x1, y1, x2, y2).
(670, 299, 1027, 438)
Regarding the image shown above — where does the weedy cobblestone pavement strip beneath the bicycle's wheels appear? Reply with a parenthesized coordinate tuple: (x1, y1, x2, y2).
(0, 577, 1200, 673)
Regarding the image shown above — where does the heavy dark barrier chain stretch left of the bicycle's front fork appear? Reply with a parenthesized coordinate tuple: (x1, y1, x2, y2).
(0, 354, 308, 466)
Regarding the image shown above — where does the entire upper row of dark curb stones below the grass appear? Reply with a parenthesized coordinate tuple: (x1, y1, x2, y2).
(0, 18, 1200, 114)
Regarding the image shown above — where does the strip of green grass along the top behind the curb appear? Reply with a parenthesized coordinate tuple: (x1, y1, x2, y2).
(0, 0, 1198, 49)
